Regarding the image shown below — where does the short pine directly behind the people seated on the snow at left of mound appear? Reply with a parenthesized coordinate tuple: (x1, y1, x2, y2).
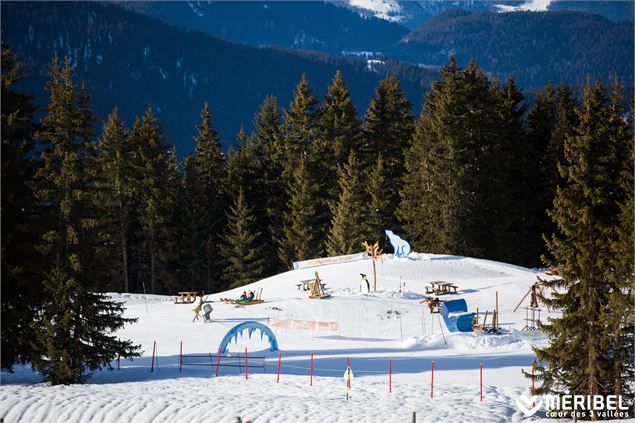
(221, 187, 264, 288)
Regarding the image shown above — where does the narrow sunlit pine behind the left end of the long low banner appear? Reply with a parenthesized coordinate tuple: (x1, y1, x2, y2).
(278, 159, 320, 268)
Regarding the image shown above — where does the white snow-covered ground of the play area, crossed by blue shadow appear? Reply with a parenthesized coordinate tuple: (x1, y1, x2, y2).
(0, 254, 628, 423)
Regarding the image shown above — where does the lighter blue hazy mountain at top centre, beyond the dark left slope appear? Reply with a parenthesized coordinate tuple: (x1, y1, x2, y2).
(117, 1, 408, 54)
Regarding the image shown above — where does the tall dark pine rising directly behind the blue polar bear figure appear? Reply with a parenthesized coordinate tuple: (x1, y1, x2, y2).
(358, 75, 413, 229)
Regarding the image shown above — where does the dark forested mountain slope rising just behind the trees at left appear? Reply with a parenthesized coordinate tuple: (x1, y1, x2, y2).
(1, 2, 436, 156)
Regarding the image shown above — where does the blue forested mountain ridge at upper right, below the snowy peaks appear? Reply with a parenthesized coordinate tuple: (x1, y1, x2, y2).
(396, 9, 634, 87)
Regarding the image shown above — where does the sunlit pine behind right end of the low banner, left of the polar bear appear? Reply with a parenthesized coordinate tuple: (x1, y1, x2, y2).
(326, 151, 366, 256)
